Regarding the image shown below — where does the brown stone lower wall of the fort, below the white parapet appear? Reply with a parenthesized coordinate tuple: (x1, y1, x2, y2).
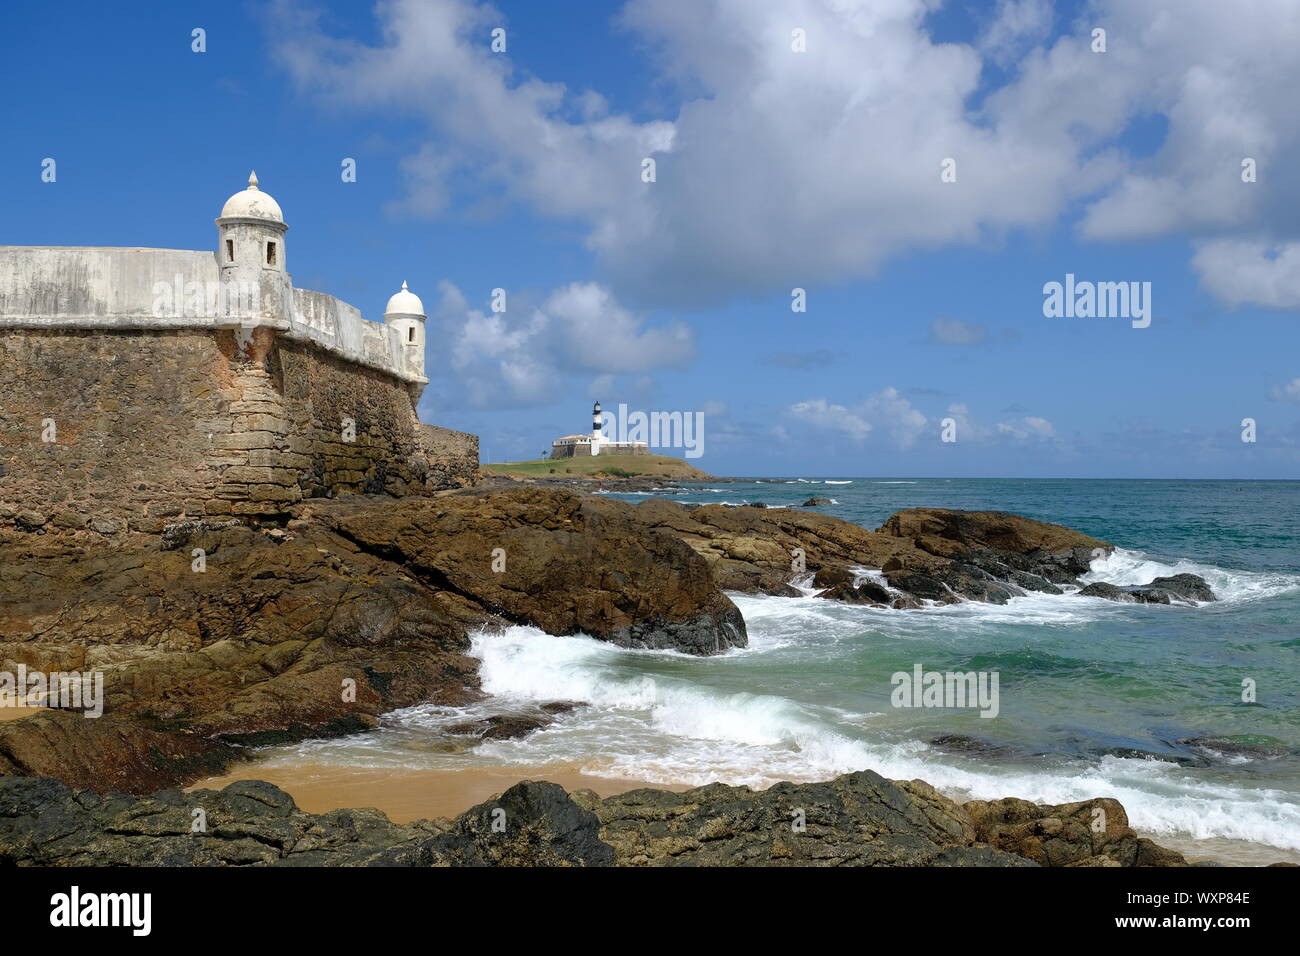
(0, 323, 478, 533)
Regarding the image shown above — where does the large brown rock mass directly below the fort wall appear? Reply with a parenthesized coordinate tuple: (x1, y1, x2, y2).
(0, 489, 745, 792)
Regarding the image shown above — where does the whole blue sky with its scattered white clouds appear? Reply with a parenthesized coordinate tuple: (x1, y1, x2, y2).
(0, 0, 1300, 477)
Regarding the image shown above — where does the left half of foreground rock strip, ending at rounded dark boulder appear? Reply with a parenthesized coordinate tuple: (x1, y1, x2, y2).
(0, 778, 614, 866)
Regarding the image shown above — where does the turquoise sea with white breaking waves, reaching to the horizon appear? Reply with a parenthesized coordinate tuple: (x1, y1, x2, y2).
(258, 479, 1300, 862)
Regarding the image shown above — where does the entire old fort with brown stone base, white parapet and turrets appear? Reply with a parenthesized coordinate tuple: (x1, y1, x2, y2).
(0, 171, 478, 535)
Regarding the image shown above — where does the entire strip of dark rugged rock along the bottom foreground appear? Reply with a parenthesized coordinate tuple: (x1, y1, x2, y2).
(0, 770, 1216, 866)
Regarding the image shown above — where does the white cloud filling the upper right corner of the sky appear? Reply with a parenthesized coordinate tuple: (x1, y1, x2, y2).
(1066, 0, 1300, 239)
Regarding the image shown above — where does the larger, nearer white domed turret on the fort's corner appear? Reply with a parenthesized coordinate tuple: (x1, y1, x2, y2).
(217, 173, 293, 321)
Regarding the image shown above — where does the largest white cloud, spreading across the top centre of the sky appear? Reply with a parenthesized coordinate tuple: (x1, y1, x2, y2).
(276, 0, 1097, 302)
